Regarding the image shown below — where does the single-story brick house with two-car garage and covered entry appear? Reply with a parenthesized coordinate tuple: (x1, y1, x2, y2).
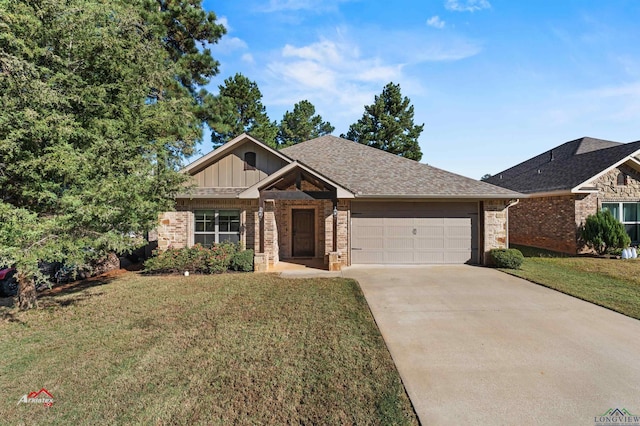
(158, 134, 521, 270)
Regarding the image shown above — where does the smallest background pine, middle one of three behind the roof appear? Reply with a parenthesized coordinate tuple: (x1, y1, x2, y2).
(278, 100, 335, 147)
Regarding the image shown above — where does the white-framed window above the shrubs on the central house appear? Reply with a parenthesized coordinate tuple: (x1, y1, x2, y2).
(194, 210, 240, 247)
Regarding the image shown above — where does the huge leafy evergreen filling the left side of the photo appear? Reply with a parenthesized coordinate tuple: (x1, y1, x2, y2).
(0, 0, 224, 309)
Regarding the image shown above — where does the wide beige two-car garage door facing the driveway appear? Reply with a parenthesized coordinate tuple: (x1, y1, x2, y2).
(351, 202, 478, 264)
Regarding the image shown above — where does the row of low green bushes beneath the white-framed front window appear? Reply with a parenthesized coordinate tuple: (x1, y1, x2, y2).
(144, 243, 248, 274)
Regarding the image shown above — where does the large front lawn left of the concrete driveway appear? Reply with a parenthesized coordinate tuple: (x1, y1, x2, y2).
(0, 273, 417, 425)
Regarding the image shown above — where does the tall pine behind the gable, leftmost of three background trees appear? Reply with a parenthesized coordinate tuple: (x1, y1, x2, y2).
(204, 73, 278, 148)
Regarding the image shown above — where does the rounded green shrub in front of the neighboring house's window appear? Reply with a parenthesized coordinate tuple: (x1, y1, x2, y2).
(581, 210, 631, 254)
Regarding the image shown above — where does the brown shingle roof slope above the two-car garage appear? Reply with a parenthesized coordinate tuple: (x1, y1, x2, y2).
(282, 135, 520, 198)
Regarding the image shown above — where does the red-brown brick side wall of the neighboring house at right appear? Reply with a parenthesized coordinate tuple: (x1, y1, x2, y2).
(509, 195, 576, 253)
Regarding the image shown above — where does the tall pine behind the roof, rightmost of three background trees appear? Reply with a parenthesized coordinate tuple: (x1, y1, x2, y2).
(340, 83, 424, 161)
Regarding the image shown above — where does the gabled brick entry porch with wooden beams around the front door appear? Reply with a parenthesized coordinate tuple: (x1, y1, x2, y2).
(240, 163, 353, 271)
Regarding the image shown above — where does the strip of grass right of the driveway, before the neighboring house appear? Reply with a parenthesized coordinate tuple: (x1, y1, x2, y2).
(503, 247, 640, 319)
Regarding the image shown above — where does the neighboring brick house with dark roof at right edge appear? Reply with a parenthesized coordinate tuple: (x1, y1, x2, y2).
(486, 137, 640, 254)
